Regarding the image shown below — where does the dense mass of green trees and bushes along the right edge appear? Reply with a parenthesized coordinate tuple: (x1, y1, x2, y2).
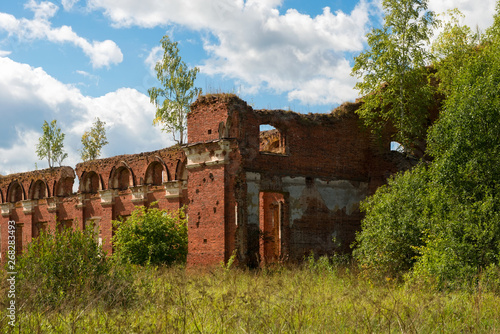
(355, 4, 500, 289)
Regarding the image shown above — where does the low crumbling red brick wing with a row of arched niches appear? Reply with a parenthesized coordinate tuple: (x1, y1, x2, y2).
(0, 147, 187, 253)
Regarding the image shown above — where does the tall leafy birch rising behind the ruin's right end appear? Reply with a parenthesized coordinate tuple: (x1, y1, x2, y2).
(352, 0, 436, 154)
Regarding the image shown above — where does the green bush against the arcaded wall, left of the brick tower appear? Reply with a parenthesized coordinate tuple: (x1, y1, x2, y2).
(113, 206, 187, 265)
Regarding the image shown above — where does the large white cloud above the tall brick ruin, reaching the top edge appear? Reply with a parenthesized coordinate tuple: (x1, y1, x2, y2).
(89, 0, 370, 104)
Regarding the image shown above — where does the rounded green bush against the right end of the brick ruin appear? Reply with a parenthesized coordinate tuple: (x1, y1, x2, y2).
(353, 165, 431, 276)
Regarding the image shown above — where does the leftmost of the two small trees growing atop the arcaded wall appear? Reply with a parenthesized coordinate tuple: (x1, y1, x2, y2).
(36, 120, 68, 168)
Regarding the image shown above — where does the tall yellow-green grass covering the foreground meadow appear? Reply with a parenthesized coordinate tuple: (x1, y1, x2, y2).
(0, 259, 500, 333)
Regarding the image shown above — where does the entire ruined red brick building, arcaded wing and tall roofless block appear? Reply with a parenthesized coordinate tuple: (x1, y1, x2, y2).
(0, 94, 401, 265)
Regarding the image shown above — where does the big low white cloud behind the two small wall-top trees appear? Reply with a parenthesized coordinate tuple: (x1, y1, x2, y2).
(0, 57, 174, 174)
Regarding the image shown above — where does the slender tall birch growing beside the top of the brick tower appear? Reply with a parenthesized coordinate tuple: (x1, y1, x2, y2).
(148, 35, 201, 145)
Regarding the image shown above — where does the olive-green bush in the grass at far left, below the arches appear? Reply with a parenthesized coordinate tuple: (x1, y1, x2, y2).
(16, 224, 110, 307)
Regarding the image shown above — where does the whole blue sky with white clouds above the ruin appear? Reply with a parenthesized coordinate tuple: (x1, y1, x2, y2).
(0, 0, 495, 175)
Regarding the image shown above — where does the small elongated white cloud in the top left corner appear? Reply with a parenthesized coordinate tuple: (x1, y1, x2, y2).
(0, 0, 123, 68)
